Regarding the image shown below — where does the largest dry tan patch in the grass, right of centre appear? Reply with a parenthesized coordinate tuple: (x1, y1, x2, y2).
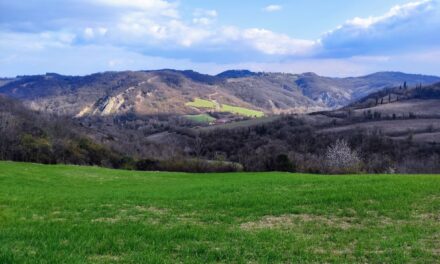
(240, 214, 358, 230)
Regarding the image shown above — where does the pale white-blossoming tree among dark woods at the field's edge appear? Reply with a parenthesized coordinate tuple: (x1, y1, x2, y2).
(325, 139, 361, 173)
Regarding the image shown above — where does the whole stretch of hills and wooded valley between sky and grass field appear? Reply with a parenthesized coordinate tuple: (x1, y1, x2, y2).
(0, 70, 440, 173)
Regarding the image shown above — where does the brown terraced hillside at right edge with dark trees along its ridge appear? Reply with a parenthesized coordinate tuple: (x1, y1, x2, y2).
(314, 83, 440, 144)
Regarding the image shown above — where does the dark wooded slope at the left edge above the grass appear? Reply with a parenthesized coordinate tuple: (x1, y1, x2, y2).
(0, 96, 122, 167)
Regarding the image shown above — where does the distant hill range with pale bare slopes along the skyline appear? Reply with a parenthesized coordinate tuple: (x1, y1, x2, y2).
(0, 70, 440, 117)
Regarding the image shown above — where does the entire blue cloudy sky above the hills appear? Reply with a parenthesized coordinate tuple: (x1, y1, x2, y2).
(0, 0, 440, 77)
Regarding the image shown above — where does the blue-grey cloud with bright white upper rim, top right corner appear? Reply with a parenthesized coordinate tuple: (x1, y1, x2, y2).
(321, 0, 440, 56)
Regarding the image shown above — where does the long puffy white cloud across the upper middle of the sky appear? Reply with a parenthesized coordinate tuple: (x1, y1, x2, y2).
(79, 0, 317, 56)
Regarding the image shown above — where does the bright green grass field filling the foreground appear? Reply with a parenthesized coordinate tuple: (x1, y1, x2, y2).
(0, 162, 440, 263)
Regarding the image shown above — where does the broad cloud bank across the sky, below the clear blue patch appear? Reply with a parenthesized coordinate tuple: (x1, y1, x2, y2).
(0, 0, 440, 76)
